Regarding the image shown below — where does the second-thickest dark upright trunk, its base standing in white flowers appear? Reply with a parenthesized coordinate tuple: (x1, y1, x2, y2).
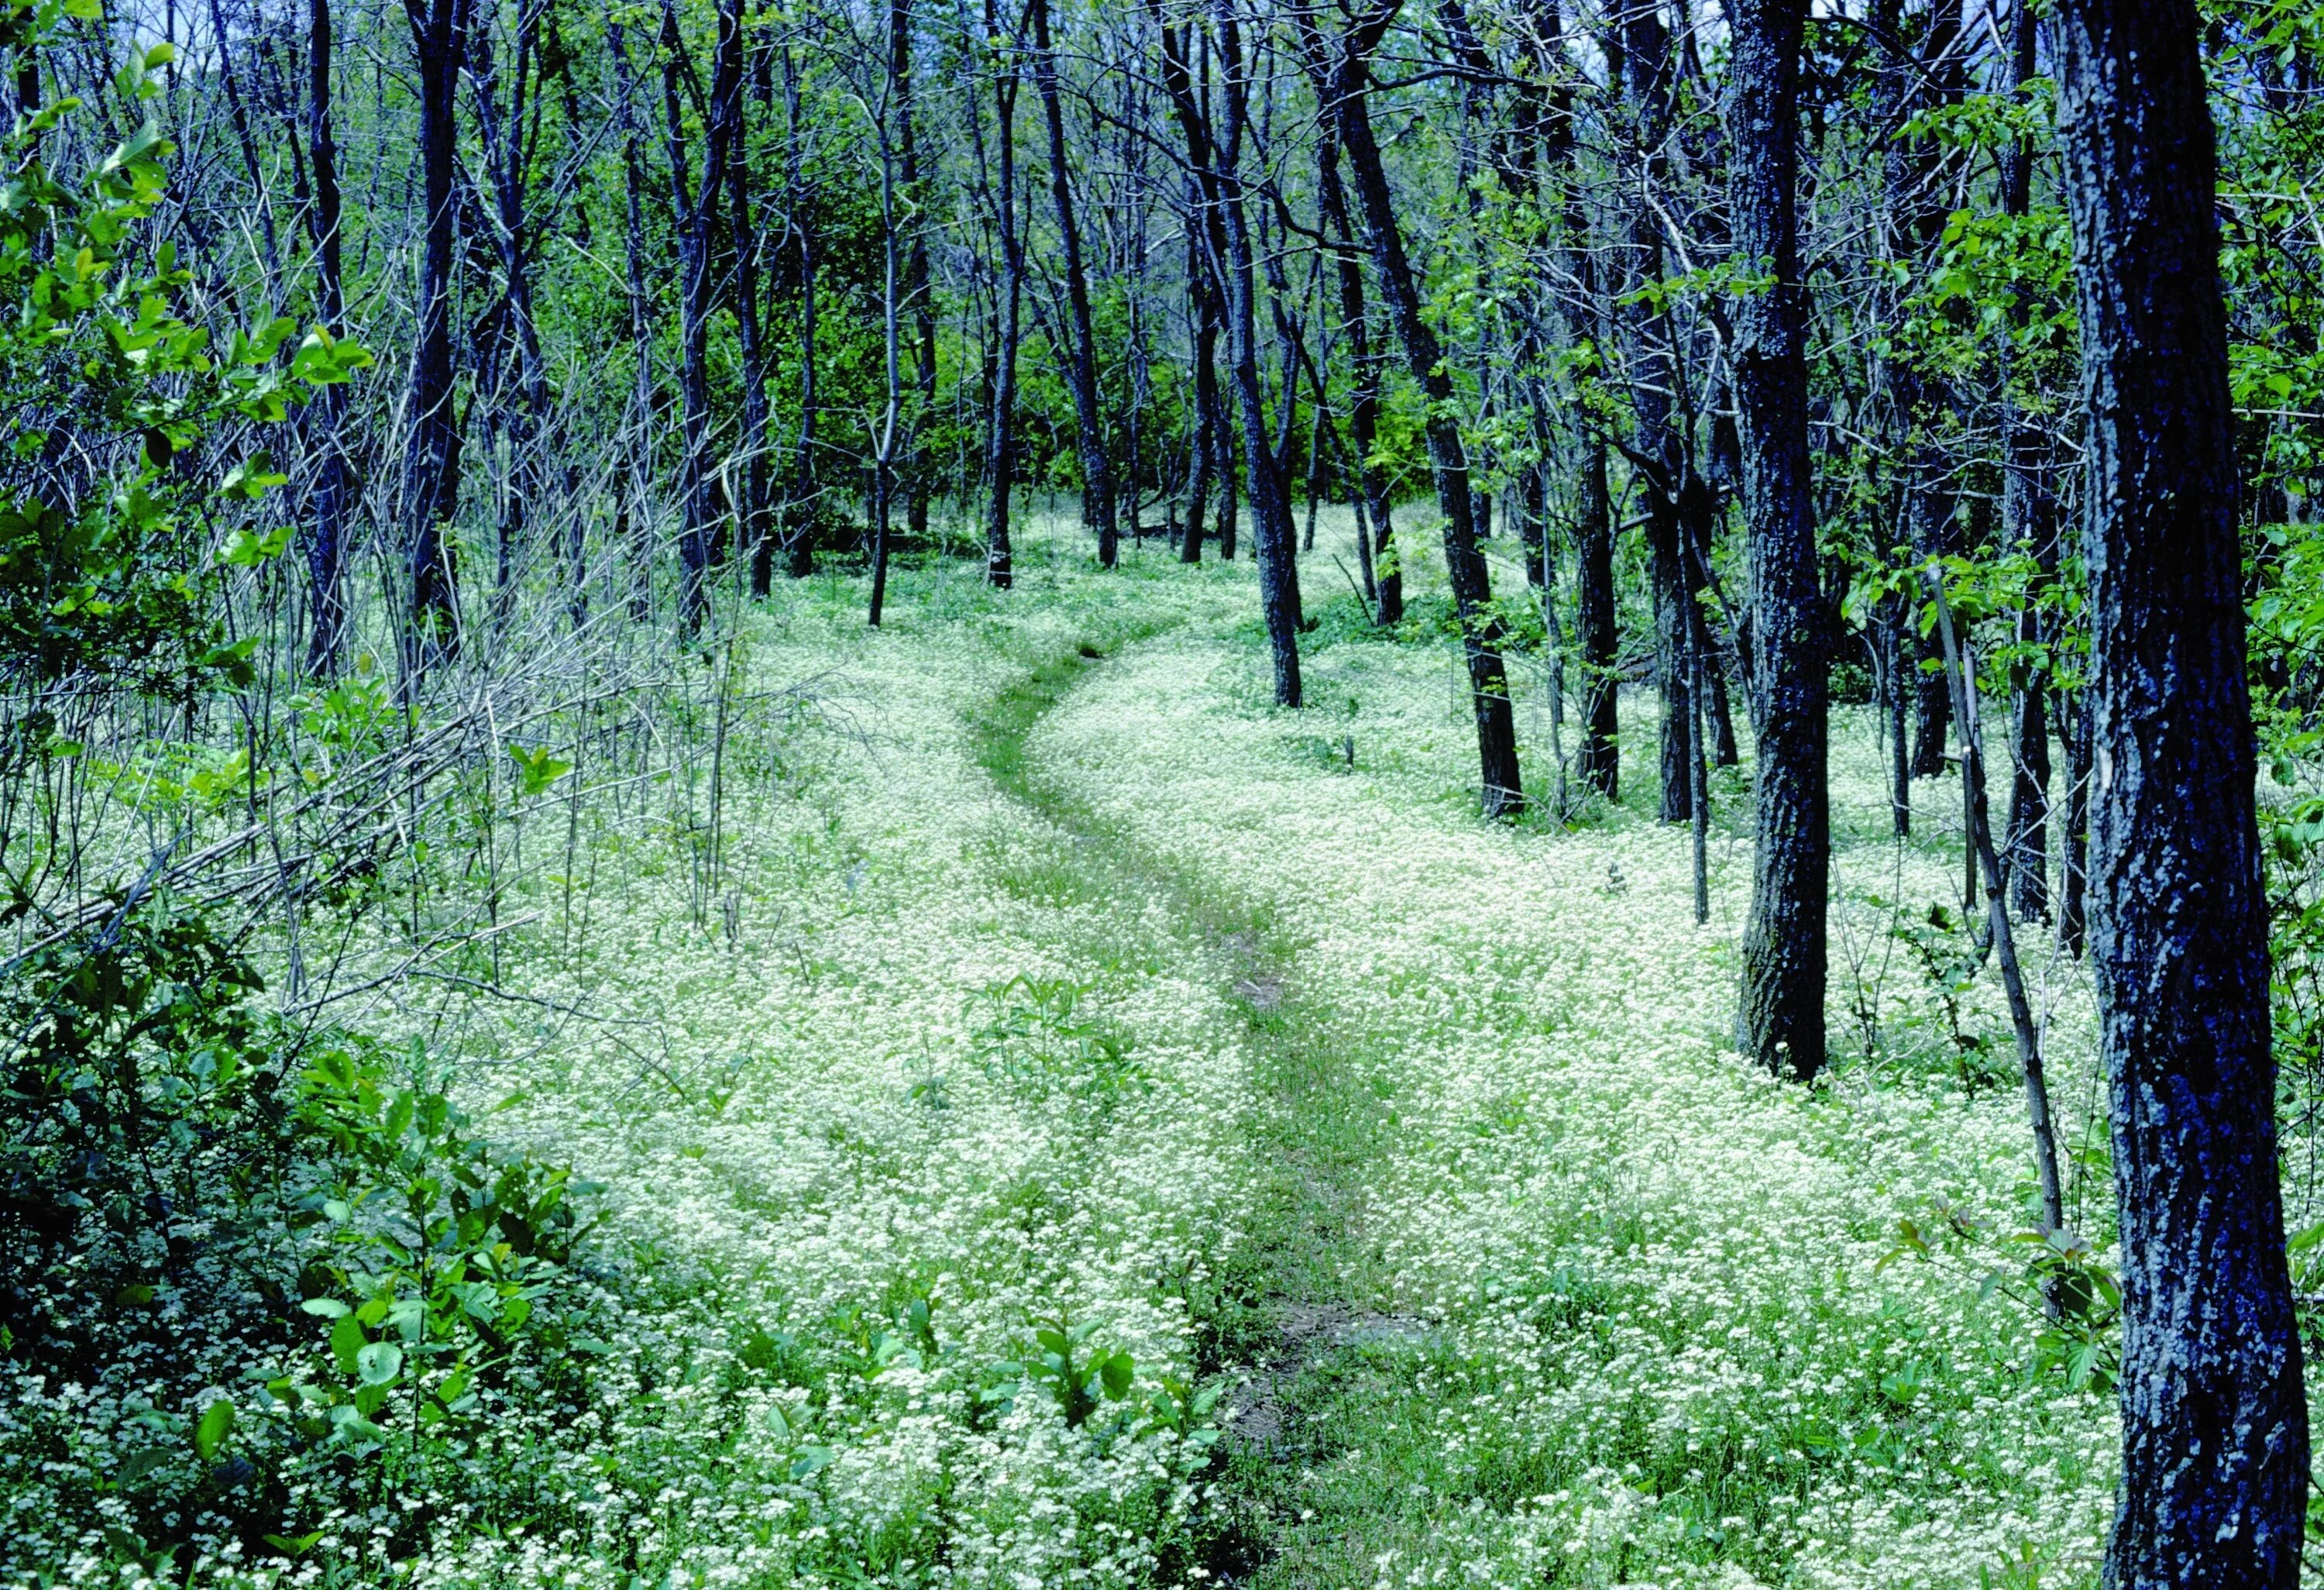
(1727, 0, 1831, 1079)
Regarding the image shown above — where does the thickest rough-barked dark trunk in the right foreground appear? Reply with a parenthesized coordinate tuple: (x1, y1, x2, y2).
(2052, 0, 2308, 1590)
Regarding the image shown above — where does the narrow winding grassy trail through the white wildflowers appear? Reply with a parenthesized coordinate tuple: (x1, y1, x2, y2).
(969, 623, 1394, 1585)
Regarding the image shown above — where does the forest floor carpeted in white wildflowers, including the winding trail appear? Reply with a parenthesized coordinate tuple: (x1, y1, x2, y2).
(222, 518, 2113, 1590)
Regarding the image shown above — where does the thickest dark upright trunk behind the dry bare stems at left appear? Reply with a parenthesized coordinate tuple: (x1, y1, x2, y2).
(404, 0, 467, 672)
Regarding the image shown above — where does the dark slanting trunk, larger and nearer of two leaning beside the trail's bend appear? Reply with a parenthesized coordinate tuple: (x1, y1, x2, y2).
(1308, 14, 1525, 818)
